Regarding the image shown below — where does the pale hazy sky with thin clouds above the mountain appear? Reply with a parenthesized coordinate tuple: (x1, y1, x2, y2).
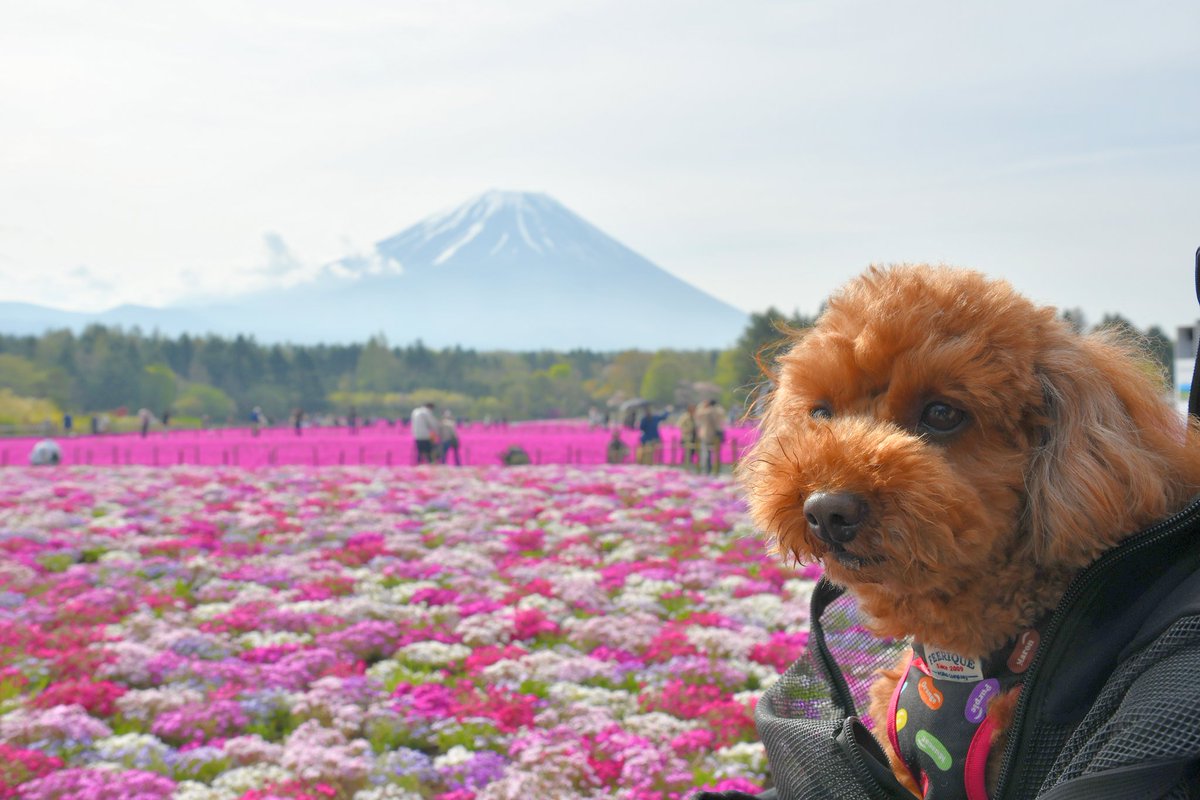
(0, 0, 1200, 332)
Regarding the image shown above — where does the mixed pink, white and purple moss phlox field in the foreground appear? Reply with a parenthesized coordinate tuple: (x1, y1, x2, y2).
(0, 465, 816, 800)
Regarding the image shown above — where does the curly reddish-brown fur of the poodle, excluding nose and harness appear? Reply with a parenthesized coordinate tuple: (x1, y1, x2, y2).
(739, 265, 1200, 790)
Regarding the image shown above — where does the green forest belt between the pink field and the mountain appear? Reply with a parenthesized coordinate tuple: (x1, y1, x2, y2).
(0, 308, 1171, 431)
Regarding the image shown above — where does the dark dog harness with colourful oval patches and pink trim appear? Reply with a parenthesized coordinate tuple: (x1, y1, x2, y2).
(888, 628, 1039, 800)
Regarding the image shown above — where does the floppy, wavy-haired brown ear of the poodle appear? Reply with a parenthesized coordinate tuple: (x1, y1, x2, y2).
(1026, 326, 1196, 567)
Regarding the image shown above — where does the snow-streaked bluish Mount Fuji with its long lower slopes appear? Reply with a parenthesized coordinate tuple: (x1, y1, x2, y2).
(0, 191, 748, 350)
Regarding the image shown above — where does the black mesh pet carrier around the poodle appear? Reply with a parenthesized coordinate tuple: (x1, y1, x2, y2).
(697, 499, 1200, 800)
